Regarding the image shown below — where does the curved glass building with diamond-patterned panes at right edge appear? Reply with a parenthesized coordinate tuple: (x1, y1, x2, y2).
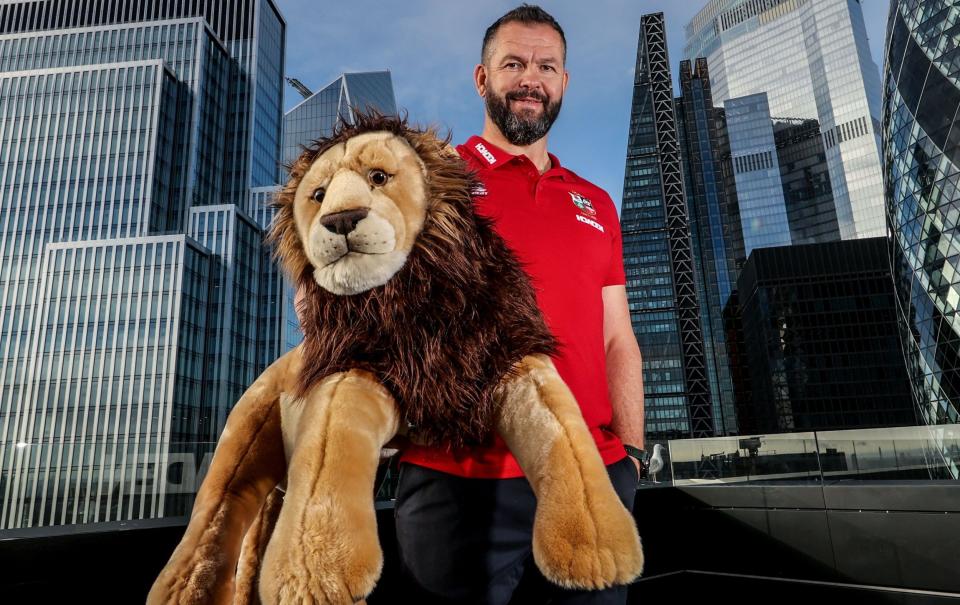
(883, 0, 960, 424)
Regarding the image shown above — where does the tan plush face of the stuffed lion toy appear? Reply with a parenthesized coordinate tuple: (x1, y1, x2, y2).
(293, 132, 428, 295)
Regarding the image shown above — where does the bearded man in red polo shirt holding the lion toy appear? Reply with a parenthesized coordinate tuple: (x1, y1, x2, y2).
(396, 5, 643, 604)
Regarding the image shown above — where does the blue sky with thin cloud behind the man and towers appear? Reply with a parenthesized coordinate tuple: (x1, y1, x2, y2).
(276, 0, 888, 207)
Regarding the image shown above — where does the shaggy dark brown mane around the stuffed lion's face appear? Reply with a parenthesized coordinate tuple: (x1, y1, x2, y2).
(269, 114, 557, 447)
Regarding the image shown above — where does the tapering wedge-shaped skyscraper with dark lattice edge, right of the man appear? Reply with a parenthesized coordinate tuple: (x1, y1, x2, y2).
(621, 13, 714, 439)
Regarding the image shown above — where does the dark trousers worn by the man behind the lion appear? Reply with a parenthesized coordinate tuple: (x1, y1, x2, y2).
(395, 457, 637, 605)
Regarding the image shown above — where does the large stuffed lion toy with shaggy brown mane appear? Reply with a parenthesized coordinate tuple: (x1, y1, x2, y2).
(148, 115, 643, 605)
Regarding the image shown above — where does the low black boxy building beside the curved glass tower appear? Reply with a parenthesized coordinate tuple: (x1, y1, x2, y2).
(734, 237, 916, 434)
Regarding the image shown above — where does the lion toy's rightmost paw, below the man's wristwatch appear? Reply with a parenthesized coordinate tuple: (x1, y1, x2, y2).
(533, 490, 643, 590)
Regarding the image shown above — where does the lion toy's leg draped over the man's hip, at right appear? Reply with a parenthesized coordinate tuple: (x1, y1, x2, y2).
(497, 356, 643, 589)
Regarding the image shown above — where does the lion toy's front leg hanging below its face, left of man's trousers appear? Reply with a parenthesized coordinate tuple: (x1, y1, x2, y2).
(260, 370, 400, 605)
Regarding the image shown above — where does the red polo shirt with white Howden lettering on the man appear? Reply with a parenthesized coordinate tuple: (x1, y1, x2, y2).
(401, 137, 626, 478)
